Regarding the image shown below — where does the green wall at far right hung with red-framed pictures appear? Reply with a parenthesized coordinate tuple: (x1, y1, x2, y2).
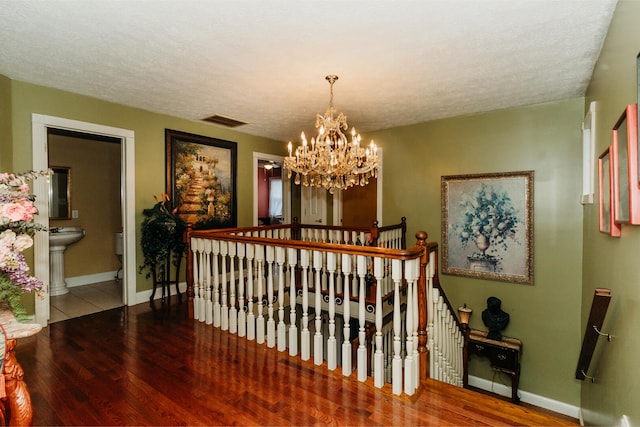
(582, 0, 640, 426)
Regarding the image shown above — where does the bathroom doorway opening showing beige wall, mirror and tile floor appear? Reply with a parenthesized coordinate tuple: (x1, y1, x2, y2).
(47, 128, 123, 323)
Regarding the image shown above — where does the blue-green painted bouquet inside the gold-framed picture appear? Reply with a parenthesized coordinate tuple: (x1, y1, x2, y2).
(456, 183, 520, 258)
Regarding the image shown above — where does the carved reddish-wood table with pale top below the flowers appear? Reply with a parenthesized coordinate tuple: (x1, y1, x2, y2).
(0, 306, 42, 426)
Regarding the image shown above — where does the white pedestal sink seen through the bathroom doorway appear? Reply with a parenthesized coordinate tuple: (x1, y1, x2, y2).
(49, 227, 84, 297)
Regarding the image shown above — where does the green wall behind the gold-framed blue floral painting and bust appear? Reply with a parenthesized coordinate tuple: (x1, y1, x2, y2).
(367, 98, 584, 406)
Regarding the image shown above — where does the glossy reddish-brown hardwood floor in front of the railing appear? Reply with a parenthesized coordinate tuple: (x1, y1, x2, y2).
(16, 297, 575, 426)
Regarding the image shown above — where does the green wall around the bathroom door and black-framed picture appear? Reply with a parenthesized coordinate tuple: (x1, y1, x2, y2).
(8, 80, 286, 291)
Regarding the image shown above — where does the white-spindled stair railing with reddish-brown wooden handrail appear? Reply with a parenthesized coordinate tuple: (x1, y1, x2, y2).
(185, 229, 464, 395)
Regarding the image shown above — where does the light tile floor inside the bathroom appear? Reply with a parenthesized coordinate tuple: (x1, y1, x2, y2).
(49, 280, 123, 323)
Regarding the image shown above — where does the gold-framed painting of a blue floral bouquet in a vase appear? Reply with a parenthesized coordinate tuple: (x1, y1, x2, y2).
(441, 171, 533, 285)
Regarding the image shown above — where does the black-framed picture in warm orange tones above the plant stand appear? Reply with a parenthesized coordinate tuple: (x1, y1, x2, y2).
(165, 129, 238, 229)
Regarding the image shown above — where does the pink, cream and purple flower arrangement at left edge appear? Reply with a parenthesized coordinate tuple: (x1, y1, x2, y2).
(0, 171, 50, 321)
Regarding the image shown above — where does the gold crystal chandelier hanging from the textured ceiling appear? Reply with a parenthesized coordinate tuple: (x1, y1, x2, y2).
(284, 75, 378, 194)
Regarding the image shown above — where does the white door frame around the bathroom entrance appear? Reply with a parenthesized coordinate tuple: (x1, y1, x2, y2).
(31, 113, 137, 326)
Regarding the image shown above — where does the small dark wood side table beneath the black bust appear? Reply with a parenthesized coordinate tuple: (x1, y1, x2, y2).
(469, 329, 522, 403)
